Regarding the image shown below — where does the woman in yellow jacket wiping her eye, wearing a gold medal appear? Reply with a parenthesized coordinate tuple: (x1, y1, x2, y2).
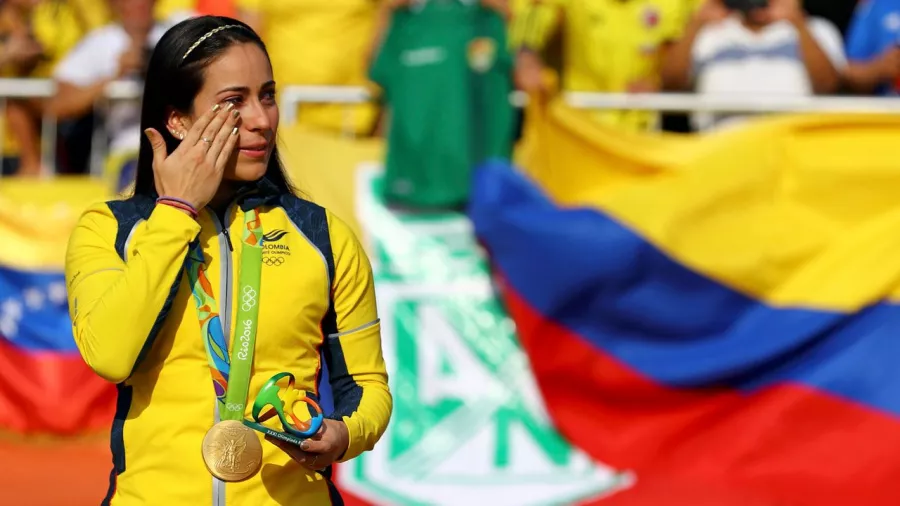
(66, 16, 392, 506)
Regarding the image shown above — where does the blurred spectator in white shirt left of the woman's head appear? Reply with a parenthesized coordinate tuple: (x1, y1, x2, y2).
(50, 0, 166, 152)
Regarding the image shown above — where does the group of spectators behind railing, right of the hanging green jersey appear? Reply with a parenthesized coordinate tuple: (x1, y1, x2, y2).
(513, 0, 880, 131)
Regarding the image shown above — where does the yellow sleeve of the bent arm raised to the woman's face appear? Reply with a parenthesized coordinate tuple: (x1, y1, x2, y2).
(66, 204, 200, 383)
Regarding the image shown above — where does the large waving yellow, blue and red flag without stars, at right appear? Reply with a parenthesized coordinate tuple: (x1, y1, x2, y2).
(470, 97, 900, 506)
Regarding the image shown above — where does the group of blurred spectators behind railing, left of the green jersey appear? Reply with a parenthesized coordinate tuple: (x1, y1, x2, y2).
(0, 0, 379, 176)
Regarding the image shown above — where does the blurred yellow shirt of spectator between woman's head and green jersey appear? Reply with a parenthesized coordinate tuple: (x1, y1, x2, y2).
(237, 0, 378, 133)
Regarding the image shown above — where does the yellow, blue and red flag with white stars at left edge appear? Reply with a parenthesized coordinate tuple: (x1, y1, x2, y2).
(0, 178, 115, 435)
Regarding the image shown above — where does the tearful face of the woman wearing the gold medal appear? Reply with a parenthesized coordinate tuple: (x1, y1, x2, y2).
(182, 43, 278, 181)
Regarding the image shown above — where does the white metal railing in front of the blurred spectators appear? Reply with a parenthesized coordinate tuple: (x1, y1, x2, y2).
(0, 78, 900, 180)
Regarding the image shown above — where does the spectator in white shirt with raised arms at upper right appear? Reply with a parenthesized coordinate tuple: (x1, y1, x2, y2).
(662, 0, 847, 131)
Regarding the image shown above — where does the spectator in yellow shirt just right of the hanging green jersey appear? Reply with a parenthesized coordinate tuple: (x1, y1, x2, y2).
(510, 0, 694, 131)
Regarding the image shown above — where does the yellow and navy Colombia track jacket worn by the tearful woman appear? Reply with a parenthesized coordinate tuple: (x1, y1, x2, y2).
(66, 180, 392, 506)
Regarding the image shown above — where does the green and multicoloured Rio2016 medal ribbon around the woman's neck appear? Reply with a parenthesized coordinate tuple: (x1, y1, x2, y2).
(186, 209, 263, 420)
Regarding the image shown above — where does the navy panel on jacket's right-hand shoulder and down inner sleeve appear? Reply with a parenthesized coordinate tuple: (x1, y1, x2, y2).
(280, 195, 362, 420)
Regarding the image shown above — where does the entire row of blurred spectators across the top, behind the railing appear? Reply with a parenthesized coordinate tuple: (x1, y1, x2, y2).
(0, 0, 900, 180)
